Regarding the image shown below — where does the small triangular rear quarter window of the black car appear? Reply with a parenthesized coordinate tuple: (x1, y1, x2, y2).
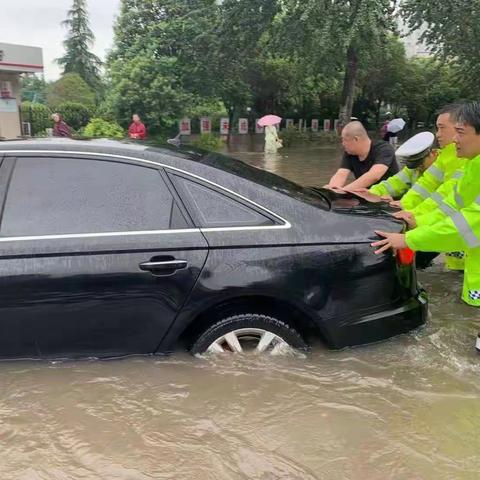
(174, 175, 274, 228)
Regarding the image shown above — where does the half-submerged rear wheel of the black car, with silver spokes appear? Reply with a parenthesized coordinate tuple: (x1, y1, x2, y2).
(190, 313, 308, 355)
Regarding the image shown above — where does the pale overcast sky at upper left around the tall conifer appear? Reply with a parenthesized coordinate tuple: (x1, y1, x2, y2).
(0, 0, 120, 80)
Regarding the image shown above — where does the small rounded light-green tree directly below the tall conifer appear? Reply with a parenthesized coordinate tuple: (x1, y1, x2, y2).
(47, 73, 95, 109)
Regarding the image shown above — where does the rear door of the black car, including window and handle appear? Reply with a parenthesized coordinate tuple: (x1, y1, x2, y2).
(0, 154, 208, 357)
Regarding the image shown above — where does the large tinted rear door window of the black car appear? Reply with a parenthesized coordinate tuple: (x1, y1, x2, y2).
(0, 157, 187, 237)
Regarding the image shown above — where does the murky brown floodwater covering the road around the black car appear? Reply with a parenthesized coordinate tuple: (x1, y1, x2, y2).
(0, 141, 480, 480)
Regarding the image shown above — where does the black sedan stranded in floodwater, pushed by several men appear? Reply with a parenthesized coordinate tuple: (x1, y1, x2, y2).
(0, 140, 427, 358)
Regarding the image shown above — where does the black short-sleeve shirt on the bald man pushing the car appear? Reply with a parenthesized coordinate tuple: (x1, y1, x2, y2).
(340, 140, 399, 181)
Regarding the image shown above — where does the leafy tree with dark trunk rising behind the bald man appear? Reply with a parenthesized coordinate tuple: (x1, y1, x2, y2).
(280, 0, 396, 124)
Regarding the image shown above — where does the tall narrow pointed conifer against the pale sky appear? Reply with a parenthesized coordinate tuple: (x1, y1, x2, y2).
(57, 0, 102, 89)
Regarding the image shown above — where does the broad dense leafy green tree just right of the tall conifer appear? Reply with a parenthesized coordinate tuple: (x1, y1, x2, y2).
(106, 0, 216, 131)
